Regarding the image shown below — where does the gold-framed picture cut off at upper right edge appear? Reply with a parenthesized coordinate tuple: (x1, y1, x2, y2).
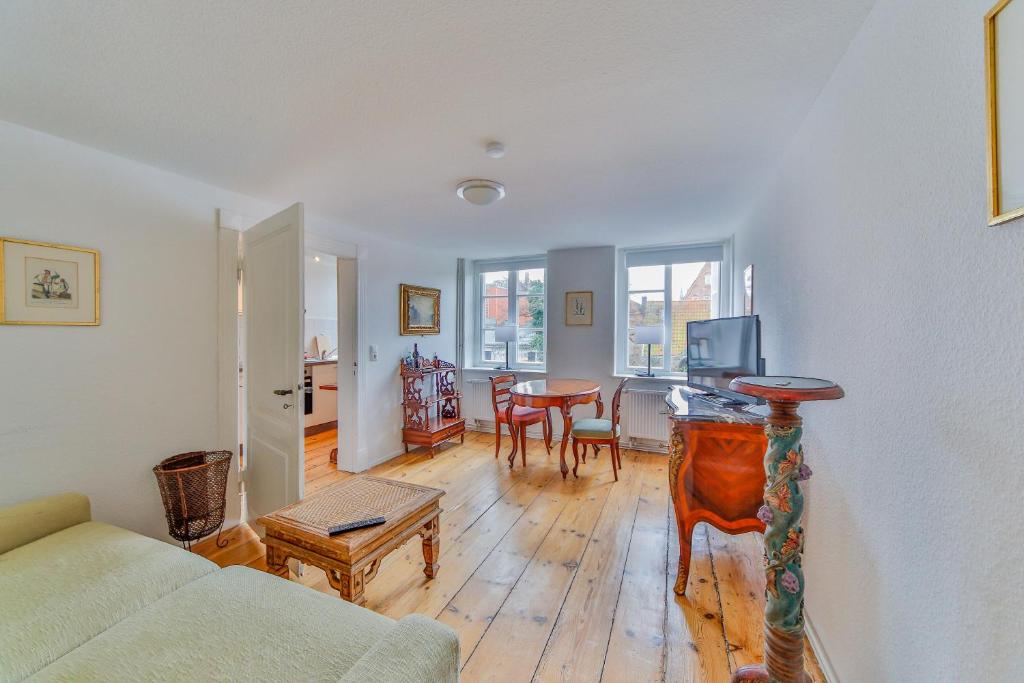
(985, 0, 1024, 225)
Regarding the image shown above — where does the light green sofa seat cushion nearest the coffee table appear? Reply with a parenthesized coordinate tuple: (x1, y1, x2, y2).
(31, 566, 395, 683)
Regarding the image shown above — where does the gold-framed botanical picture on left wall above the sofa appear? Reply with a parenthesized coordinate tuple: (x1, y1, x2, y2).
(0, 238, 99, 325)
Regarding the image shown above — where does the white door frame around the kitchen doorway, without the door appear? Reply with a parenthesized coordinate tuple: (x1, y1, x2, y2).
(216, 209, 368, 528)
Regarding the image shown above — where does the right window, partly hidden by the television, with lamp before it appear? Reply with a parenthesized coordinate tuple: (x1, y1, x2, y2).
(617, 244, 729, 375)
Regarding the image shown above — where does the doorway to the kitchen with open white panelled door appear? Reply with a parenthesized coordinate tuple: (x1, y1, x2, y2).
(218, 205, 360, 528)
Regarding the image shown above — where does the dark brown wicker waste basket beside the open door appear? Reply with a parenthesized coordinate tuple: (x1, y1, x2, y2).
(153, 451, 231, 550)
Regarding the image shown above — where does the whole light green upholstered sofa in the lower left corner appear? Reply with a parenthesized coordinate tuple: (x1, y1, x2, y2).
(0, 494, 459, 683)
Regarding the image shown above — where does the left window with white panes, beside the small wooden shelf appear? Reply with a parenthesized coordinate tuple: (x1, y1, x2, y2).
(474, 257, 547, 370)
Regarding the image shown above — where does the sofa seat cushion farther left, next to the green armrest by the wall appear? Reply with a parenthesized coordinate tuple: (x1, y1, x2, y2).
(0, 522, 217, 681)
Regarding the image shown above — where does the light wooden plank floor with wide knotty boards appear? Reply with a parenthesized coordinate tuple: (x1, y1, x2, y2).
(196, 432, 824, 683)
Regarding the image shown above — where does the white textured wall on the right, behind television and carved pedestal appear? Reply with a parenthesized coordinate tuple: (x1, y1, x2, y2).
(736, 0, 1024, 681)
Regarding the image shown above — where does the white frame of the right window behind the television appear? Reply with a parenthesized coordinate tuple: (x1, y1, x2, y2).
(615, 238, 733, 380)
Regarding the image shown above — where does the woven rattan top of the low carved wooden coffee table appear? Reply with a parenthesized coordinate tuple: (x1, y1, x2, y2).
(261, 475, 444, 540)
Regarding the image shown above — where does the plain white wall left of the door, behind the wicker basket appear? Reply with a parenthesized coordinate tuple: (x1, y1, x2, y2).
(0, 122, 272, 538)
